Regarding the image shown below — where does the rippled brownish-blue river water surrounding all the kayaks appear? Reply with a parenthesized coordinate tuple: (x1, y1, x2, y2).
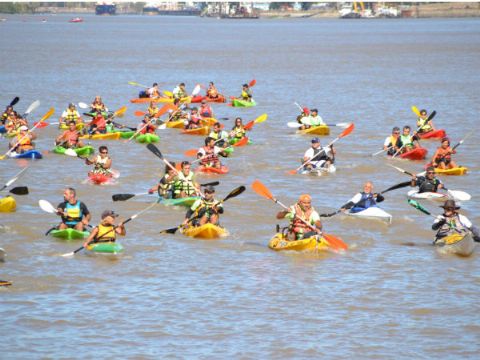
(0, 15, 480, 359)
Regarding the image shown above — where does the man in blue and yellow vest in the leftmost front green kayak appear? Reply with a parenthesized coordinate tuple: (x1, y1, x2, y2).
(57, 188, 91, 231)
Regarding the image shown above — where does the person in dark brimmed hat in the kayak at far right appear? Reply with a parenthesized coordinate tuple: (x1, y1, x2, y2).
(432, 200, 480, 244)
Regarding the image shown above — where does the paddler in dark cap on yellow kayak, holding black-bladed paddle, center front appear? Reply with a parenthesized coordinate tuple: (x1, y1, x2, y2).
(183, 186, 223, 226)
